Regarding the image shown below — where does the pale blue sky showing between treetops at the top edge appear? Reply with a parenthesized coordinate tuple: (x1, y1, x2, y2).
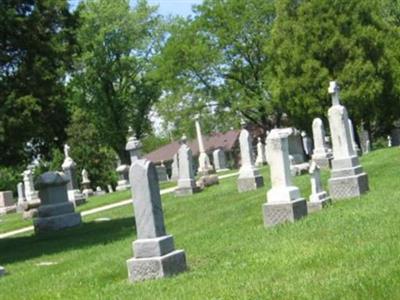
(69, 0, 203, 17)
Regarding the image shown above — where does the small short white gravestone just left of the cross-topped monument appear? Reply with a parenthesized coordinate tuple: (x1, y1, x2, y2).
(307, 161, 331, 213)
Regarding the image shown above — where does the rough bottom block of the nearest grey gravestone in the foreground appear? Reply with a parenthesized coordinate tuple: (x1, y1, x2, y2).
(126, 250, 186, 282)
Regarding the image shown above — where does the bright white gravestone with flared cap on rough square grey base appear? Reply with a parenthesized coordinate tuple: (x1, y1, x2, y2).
(263, 129, 307, 227)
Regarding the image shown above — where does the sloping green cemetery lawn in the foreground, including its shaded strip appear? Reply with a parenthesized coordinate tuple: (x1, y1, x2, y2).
(0, 148, 400, 299)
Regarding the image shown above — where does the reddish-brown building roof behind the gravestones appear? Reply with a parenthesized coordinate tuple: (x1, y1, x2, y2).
(145, 130, 240, 162)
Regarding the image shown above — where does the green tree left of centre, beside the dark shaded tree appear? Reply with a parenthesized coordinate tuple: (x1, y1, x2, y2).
(70, 0, 160, 163)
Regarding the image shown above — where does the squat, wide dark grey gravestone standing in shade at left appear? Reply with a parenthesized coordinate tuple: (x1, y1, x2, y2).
(33, 172, 82, 233)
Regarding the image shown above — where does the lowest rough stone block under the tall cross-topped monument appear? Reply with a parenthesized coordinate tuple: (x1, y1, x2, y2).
(328, 173, 369, 199)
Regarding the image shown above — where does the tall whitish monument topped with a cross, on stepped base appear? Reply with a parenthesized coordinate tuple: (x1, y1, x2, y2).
(328, 81, 369, 199)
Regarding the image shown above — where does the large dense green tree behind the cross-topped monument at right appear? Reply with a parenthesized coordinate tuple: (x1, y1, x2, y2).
(268, 0, 400, 135)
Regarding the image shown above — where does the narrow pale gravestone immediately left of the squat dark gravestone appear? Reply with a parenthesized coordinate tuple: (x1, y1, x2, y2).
(22, 167, 40, 219)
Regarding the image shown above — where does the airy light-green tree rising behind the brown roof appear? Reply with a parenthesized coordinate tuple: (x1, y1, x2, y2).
(158, 0, 275, 138)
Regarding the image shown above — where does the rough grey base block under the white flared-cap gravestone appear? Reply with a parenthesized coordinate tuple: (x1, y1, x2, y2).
(263, 198, 307, 228)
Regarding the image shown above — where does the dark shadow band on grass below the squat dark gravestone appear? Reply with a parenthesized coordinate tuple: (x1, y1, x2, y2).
(0, 217, 136, 264)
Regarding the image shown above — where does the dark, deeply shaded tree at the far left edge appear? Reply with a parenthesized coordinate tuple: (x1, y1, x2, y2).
(0, 0, 76, 166)
